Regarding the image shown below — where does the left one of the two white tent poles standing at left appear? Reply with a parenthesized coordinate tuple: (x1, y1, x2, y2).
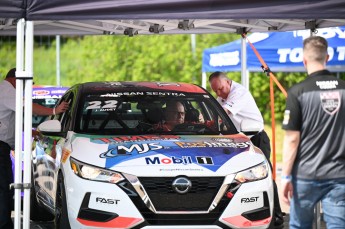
(14, 19, 25, 229)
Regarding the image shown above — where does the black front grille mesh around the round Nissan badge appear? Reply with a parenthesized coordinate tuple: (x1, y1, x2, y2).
(139, 177, 224, 211)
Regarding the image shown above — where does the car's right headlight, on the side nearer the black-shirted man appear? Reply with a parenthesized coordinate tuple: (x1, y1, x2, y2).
(235, 162, 268, 183)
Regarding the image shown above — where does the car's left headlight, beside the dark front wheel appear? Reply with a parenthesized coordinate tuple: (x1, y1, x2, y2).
(70, 157, 125, 184)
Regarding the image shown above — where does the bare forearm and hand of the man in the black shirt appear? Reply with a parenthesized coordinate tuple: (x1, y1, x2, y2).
(282, 130, 301, 205)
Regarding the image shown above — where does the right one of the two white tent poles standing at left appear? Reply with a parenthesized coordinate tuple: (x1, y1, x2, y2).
(23, 21, 34, 229)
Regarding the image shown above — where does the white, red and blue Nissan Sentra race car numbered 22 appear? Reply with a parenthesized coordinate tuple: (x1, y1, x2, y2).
(31, 82, 273, 229)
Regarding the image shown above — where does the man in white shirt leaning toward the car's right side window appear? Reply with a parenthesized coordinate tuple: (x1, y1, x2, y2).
(209, 72, 284, 228)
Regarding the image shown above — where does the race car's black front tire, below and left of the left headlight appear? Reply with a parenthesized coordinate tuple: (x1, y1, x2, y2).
(54, 174, 71, 229)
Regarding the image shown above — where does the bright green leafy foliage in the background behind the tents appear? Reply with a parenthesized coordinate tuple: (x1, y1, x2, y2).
(0, 34, 345, 124)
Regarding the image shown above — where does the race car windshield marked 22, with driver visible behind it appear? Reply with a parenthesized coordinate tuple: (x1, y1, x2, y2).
(75, 92, 237, 135)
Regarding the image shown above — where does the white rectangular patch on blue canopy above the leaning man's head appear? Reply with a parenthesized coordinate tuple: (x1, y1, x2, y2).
(210, 51, 240, 67)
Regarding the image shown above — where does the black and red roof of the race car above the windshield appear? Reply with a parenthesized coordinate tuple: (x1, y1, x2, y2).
(79, 81, 208, 94)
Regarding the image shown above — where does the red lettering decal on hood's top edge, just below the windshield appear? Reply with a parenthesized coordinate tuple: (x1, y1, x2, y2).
(90, 135, 180, 144)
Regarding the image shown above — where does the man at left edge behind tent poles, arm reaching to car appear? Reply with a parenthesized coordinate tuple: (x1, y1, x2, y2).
(0, 68, 68, 229)
